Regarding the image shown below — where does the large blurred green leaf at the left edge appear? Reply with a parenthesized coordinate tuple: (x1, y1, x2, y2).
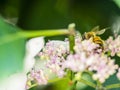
(0, 17, 25, 79)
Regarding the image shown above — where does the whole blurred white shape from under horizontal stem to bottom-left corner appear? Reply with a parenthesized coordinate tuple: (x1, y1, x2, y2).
(0, 37, 44, 90)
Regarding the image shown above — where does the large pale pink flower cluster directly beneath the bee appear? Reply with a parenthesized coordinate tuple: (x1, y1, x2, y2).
(63, 40, 118, 83)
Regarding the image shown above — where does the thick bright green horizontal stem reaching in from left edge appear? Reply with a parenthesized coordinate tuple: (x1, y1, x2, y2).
(0, 29, 69, 45)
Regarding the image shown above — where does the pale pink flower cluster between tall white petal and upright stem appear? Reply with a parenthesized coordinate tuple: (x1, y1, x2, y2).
(39, 41, 69, 77)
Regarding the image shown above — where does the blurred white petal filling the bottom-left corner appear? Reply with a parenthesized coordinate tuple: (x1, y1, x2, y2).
(0, 73, 27, 90)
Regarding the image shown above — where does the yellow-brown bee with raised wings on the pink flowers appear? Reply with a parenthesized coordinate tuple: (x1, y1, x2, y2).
(83, 26, 108, 50)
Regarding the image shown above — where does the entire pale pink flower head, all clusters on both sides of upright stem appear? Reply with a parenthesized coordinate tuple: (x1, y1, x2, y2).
(27, 32, 120, 88)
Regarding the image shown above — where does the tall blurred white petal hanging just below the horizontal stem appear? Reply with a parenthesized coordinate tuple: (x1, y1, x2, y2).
(24, 37, 44, 72)
